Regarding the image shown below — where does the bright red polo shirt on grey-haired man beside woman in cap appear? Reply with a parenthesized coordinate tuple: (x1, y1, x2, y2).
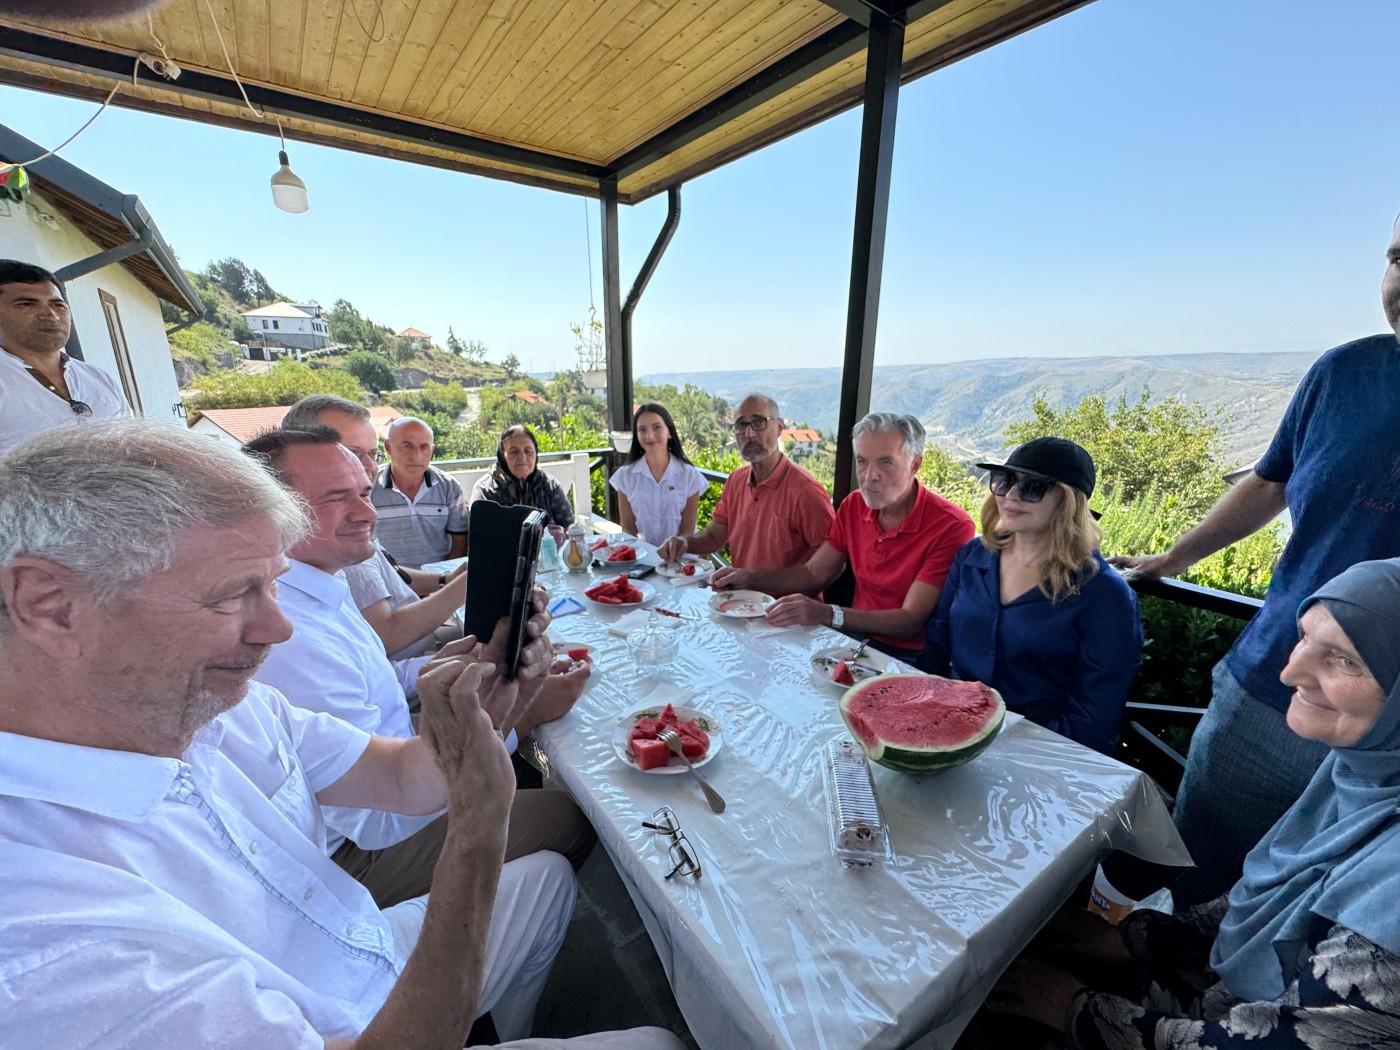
(826, 482, 977, 650)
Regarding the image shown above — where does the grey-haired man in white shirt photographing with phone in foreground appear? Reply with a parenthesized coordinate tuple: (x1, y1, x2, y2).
(0, 421, 679, 1050)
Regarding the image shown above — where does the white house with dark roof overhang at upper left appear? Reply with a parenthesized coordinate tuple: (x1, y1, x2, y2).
(0, 125, 204, 423)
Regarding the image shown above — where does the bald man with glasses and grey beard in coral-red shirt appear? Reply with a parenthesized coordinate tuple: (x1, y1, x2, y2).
(658, 393, 836, 568)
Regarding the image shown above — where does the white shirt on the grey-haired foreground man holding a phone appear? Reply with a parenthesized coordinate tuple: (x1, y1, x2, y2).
(0, 683, 400, 1050)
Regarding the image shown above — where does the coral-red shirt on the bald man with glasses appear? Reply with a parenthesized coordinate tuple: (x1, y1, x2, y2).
(711, 456, 828, 573)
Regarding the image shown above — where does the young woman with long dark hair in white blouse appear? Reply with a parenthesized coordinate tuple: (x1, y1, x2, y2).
(609, 403, 710, 543)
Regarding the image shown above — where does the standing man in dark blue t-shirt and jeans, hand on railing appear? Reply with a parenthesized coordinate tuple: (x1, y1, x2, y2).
(1110, 211, 1400, 906)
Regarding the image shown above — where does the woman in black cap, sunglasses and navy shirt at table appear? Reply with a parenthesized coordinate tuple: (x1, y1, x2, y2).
(918, 437, 1142, 753)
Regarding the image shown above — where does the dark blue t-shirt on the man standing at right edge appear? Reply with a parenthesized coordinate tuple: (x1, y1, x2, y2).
(1225, 335, 1400, 711)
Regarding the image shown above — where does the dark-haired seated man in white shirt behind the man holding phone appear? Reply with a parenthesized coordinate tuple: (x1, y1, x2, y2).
(244, 427, 596, 907)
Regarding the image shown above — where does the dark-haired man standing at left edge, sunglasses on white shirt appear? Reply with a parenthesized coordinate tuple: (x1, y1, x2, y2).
(0, 259, 132, 455)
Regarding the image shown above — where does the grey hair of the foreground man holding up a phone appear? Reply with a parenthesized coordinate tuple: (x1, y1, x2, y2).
(0, 420, 307, 623)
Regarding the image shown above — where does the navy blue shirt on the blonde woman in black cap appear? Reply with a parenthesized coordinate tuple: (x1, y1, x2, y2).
(918, 539, 1142, 753)
